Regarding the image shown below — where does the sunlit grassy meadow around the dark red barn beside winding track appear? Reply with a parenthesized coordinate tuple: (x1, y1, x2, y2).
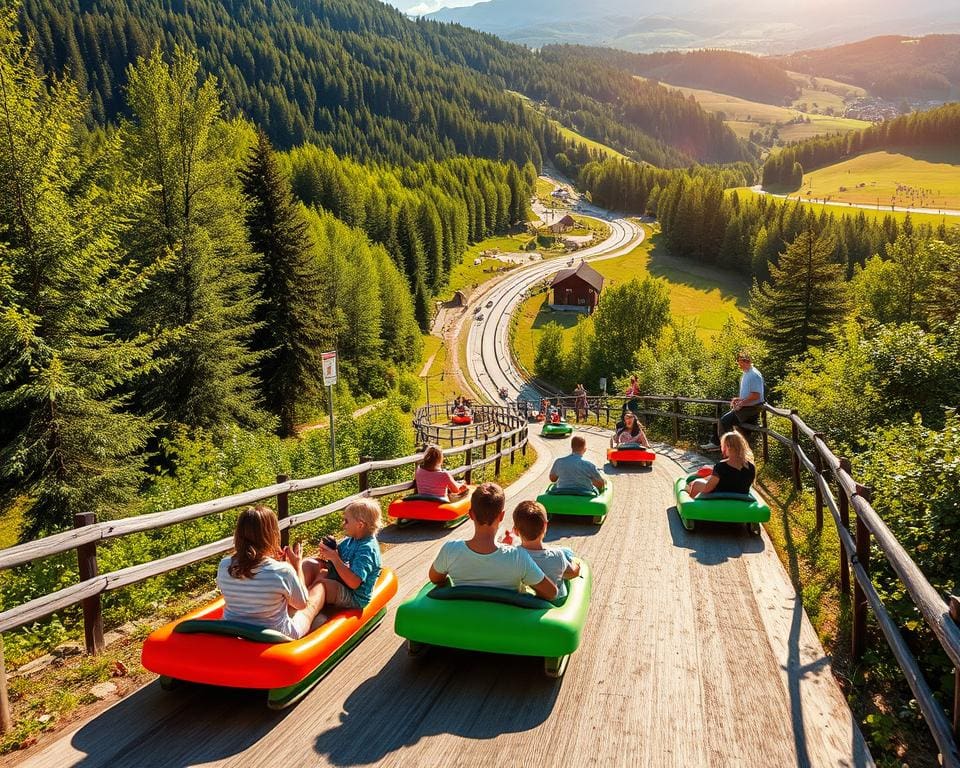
(512, 230, 748, 370)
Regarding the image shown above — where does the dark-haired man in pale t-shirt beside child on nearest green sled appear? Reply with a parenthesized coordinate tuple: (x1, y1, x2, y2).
(430, 483, 557, 600)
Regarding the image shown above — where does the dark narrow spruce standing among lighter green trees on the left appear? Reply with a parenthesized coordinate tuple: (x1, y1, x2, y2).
(240, 130, 334, 435)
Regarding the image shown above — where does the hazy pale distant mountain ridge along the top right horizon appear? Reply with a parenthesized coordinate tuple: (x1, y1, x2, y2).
(428, 0, 960, 54)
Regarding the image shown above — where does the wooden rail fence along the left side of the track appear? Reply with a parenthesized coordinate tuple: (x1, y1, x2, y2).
(0, 406, 527, 730)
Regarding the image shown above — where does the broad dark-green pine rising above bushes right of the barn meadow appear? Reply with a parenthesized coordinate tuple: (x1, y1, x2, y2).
(747, 230, 847, 373)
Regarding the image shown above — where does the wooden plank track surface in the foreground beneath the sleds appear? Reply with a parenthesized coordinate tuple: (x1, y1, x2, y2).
(16, 435, 872, 768)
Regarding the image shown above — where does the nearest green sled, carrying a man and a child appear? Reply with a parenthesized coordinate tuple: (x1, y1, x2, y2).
(394, 558, 593, 677)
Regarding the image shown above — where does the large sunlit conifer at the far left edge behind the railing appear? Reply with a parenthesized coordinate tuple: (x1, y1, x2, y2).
(0, 13, 155, 539)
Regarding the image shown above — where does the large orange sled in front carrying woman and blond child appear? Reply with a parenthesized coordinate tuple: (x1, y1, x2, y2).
(141, 568, 397, 709)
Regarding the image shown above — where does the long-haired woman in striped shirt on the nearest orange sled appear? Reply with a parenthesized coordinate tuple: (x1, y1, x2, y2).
(217, 505, 324, 639)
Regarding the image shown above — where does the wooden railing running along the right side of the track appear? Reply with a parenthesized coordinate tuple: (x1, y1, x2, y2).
(536, 395, 960, 768)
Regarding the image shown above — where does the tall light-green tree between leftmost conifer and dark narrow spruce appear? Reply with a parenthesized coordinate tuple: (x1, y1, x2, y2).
(124, 48, 263, 428)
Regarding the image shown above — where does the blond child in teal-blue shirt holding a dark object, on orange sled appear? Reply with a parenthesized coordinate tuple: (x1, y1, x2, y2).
(303, 499, 382, 610)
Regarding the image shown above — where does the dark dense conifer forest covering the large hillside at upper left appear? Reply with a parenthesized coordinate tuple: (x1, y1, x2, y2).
(21, 0, 747, 167)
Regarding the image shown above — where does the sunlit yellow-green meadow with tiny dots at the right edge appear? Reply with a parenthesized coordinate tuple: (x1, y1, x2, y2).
(800, 149, 960, 210)
